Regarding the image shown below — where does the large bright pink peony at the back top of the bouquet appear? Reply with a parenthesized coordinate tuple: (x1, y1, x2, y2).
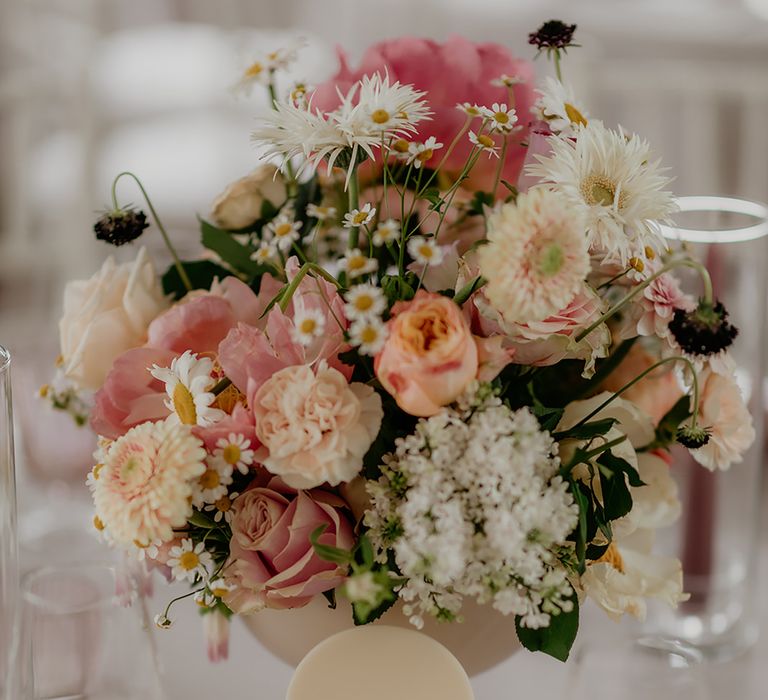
(312, 36, 535, 191)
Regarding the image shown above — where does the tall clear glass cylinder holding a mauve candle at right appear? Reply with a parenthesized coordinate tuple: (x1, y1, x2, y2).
(649, 196, 768, 660)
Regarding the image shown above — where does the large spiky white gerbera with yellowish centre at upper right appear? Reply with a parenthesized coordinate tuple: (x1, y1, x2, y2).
(527, 121, 677, 265)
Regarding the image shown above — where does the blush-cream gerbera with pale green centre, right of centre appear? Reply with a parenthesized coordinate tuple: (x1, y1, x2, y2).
(478, 188, 590, 323)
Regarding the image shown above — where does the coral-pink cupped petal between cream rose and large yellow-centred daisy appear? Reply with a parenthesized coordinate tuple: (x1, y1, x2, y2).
(91, 348, 176, 439)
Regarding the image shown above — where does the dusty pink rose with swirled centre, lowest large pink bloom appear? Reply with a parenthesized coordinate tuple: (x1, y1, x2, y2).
(224, 478, 355, 614)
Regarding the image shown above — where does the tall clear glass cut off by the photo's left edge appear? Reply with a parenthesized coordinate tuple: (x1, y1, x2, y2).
(0, 346, 18, 700)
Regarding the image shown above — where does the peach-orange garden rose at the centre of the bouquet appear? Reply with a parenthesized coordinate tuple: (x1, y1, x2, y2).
(374, 290, 479, 416)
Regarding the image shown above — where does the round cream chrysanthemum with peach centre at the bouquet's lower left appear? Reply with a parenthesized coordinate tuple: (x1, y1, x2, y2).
(93, 421, 205, 546)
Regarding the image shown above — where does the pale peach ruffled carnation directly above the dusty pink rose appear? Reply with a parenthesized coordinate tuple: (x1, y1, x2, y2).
(252, 362, 384, 489)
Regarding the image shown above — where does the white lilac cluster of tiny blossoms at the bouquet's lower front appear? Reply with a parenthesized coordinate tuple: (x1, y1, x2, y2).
(365, 386, 578, 628)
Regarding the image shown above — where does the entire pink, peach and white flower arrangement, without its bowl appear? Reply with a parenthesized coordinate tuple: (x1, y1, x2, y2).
(54, 21, 754, 660)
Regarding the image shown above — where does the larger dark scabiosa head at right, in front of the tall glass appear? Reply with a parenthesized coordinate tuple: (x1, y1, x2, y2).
(669, 300, 739, 355)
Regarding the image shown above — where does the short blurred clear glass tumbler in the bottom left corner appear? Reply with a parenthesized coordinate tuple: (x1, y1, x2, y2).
(14, 564, 163, 700)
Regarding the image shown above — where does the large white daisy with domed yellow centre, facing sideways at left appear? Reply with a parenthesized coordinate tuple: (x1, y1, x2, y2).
(150, 350, 226, 426)
